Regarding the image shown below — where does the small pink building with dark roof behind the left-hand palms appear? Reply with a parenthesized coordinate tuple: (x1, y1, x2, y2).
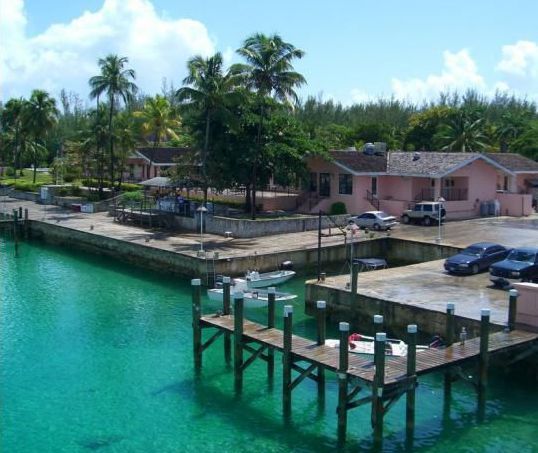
(124, 147, 191, 182)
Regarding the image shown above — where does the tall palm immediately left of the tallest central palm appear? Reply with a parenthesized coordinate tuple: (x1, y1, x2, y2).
(176, 52, 238, 203)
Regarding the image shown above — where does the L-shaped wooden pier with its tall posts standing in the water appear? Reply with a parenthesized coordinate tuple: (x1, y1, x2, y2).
(192, 277, 538, 448)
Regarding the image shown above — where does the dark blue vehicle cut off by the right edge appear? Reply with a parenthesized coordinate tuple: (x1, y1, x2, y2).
(489, 247, 538, 287)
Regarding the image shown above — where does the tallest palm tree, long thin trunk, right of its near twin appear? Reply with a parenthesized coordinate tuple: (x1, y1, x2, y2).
(232, 33, 306, 219)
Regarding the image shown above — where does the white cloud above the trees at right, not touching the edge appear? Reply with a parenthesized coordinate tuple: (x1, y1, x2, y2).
(392, 49, 486, 102)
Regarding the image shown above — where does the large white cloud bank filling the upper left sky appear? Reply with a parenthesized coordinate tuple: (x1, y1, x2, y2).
(0, 0, 215, 99)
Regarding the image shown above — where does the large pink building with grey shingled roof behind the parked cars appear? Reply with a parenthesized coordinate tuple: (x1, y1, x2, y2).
(300, 150, 538, 219)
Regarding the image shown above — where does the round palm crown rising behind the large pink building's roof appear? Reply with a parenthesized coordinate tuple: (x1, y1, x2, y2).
(436, 110, 488, 153)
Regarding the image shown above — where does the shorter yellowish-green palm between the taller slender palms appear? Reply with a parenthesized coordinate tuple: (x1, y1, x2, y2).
(135, 94, 181, 178)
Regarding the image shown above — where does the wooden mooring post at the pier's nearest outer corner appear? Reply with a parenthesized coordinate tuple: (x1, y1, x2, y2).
(372, 332, 387, 450)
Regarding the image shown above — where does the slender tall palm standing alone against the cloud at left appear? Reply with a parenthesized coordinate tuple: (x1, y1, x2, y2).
(89, 55, 138, 184)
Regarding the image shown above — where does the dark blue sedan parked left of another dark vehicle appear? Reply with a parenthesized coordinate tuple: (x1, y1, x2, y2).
(445, 242, 510, 274)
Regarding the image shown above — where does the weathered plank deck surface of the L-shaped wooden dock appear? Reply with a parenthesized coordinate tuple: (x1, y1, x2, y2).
(200, 314, 538, 386)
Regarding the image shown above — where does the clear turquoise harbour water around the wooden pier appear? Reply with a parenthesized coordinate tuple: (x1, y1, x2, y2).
(0, 239, 538, 452)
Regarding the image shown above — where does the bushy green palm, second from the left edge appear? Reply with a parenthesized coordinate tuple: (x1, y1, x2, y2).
(24, 90, 59, 184)
